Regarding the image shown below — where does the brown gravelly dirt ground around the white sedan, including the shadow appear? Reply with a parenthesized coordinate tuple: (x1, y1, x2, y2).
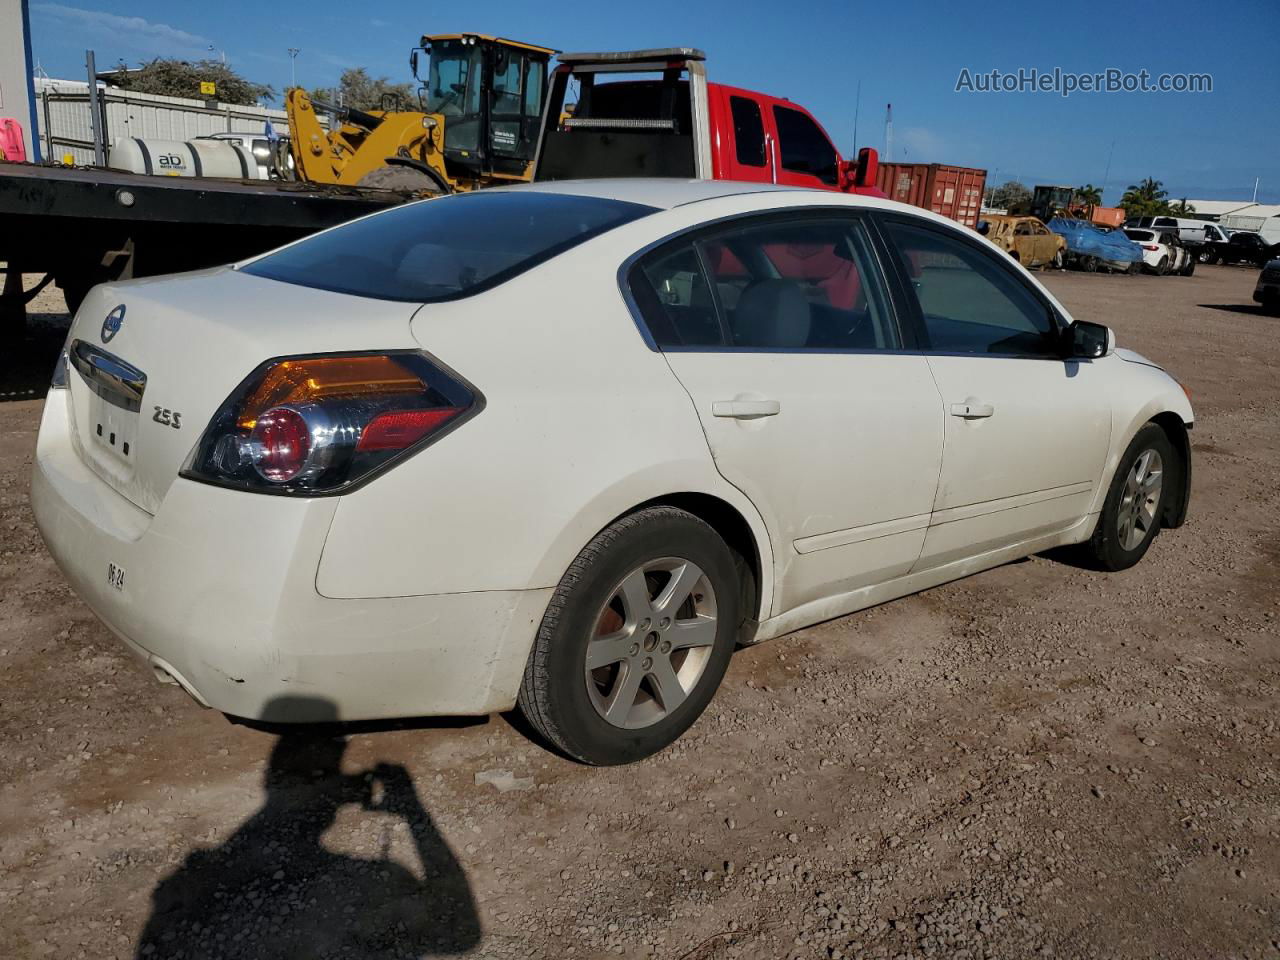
(0, 266, 1280, 960)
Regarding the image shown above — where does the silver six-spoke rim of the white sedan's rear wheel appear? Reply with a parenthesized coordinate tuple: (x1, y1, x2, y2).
(584, 557, 719, 730)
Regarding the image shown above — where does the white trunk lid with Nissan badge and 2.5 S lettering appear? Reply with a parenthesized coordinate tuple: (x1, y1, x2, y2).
(68, 268, 419, 515)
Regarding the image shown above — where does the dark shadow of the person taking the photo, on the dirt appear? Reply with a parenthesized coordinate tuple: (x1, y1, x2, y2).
(137, 698, 480, 960)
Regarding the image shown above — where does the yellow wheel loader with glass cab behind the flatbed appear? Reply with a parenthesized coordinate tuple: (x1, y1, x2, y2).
(284, 33, 557, 195)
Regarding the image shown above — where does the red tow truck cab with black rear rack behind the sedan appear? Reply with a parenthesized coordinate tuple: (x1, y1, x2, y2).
(534, 47, 884, 197)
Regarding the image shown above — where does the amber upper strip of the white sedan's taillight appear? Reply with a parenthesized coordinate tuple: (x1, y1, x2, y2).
(237, 356, 426, 430)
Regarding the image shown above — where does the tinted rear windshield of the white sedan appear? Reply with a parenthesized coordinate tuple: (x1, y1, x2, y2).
(243, 191, 657, 303)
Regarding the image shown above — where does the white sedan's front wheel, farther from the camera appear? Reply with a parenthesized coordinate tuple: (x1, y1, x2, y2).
(1084, 424, 1181, 571)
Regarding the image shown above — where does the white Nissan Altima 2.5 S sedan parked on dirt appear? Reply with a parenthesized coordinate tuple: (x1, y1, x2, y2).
(32, 180, 1193, 763)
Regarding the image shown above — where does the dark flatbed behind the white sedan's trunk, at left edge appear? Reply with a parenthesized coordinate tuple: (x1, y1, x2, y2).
(0, 163, 410, 329)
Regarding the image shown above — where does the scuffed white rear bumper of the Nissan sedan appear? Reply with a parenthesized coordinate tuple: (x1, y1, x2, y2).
(31, 390, 552, 722)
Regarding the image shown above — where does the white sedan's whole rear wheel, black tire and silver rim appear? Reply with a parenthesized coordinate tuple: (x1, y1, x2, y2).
(520, 507, 742, 764)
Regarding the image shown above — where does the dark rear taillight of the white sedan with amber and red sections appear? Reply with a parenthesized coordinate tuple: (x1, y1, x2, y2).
(182, 352, 481, 495)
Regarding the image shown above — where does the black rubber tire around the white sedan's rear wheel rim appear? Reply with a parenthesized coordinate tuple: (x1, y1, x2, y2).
(518, 507, 745, 765)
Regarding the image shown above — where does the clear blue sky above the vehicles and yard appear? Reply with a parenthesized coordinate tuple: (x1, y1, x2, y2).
(31, 0, 1280, 204)
